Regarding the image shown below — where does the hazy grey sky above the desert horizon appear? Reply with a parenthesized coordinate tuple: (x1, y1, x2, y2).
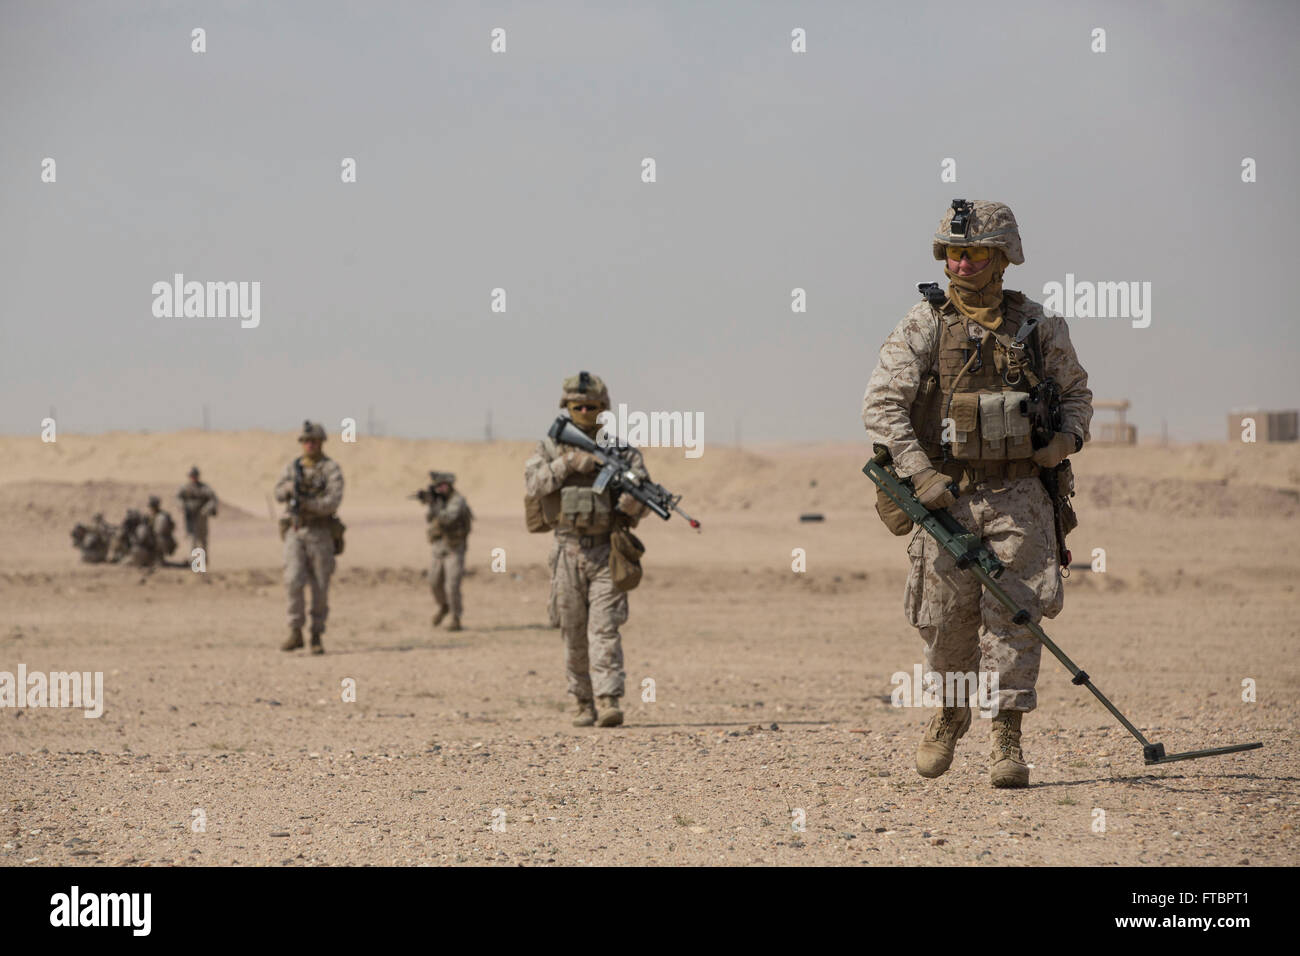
(0, 0, 1300, 444)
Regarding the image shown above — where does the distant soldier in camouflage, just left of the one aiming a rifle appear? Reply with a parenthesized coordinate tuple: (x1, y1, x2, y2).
(276, 421, 343, 654)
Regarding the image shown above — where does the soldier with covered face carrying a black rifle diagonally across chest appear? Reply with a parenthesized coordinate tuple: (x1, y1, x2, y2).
(524, 372, 649, 727)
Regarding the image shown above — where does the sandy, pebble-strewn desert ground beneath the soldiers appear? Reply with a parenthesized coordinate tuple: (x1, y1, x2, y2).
(0, 432, 1300, 866)
